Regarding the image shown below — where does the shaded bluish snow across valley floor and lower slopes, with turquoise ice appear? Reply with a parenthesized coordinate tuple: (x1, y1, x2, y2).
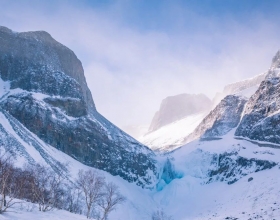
(0, 81, 280, 220)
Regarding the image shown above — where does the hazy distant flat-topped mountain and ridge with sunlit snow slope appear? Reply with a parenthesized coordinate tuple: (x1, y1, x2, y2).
(139, 69, 268, 151)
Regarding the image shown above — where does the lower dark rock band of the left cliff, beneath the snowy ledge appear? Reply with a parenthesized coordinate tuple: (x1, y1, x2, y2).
(1, 93, 156, 185)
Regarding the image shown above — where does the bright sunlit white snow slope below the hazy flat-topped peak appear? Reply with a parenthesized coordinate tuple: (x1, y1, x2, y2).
(139, 113, 206, 151)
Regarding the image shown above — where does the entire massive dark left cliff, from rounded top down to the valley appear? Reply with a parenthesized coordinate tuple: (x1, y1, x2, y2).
(0, 27, 157, 186)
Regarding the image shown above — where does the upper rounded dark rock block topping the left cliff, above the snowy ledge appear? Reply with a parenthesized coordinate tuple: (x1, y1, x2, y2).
(0, 27, 95, 110)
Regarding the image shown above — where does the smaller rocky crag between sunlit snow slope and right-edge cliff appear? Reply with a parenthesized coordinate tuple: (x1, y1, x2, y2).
(185, 95, 247, 142)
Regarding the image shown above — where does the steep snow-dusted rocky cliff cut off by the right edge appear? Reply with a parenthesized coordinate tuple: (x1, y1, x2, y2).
(235, 51, 280, 143)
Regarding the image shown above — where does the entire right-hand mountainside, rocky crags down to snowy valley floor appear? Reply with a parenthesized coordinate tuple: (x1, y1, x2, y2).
(149, 66, 280, 219)
